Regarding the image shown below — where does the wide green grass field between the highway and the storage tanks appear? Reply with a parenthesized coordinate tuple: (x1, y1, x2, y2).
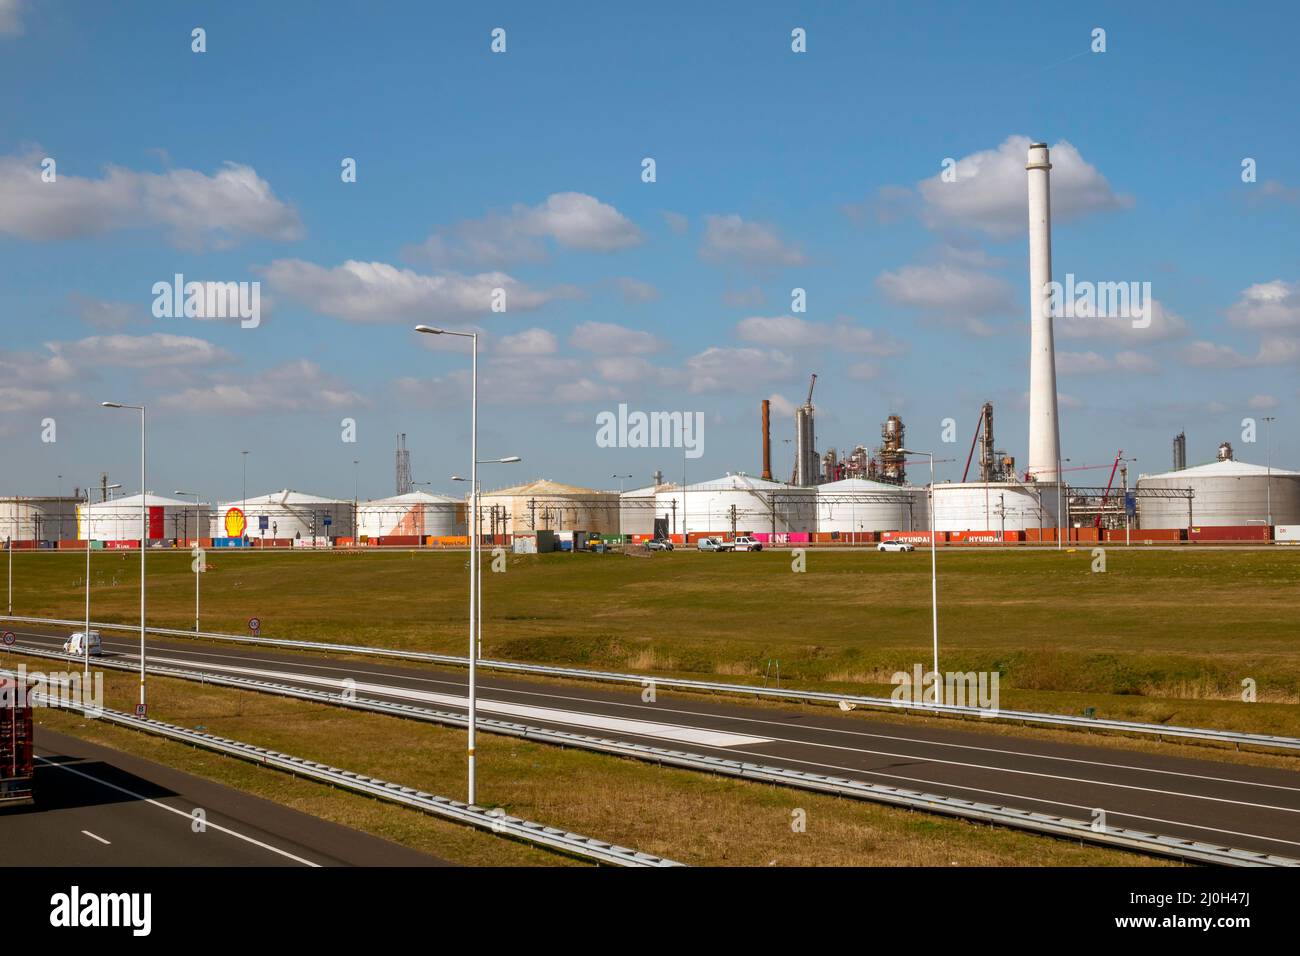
(10, 548, 1300, 734)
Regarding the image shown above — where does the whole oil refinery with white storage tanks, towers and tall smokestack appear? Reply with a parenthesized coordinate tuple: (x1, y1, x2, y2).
(0, 143, 1300, 548)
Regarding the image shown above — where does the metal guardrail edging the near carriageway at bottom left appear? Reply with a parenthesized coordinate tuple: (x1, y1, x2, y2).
(0, 654, 683, 868)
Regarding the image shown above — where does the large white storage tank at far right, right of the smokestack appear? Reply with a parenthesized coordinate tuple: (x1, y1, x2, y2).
(1138, 458, 1300, 528)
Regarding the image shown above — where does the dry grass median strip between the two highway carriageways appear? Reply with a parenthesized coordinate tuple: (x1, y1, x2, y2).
(12, 656, 1169, 866)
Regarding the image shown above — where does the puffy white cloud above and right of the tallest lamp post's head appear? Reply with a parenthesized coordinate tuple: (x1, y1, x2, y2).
(408, 193, 645, 268)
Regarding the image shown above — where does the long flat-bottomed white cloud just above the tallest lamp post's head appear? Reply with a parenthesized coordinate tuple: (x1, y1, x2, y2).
(261, 259, 576, 323)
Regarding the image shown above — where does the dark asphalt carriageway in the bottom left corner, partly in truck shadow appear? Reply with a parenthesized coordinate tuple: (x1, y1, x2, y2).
(0, 726, 442, 868)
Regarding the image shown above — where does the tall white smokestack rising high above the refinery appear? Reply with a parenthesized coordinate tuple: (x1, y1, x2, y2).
(1024, 143, 1061, 481)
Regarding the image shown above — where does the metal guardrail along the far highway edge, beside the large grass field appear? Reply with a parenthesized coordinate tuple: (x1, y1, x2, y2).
(10, 614, 1300, 752)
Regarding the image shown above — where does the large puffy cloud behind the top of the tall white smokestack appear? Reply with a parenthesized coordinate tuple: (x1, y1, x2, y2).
(918, 135, 1132, 239)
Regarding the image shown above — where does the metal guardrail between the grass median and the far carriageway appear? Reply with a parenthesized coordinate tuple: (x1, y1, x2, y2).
(7, 649, 1300, 866)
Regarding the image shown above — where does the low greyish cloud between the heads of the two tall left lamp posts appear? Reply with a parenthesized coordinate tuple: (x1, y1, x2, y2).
(160, 359, 371, 415)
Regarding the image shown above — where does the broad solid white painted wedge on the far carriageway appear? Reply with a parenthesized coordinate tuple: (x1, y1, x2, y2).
(150, 657, 771, 747)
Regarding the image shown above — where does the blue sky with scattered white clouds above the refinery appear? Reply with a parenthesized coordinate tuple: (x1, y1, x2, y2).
(0, 0, 1300, 498)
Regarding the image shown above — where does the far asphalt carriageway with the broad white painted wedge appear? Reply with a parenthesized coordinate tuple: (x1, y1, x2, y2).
(10, 628, 1300, 858)
